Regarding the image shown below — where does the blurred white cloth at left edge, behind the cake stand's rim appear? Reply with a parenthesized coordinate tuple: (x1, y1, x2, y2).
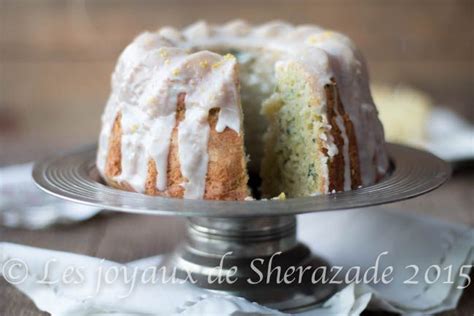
(0, 163, 100, 229)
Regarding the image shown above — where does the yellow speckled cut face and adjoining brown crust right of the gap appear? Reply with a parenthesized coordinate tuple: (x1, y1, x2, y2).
(261, 52, 361, 197)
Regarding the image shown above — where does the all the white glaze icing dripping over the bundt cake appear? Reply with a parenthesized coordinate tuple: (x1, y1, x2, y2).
(97, 20, 388, 199)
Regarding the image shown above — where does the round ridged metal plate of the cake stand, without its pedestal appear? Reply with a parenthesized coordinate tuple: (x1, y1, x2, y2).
(32, 143, 451, 217)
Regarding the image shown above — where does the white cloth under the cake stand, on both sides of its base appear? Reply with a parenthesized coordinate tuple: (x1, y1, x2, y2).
(0, 208, 474, 316)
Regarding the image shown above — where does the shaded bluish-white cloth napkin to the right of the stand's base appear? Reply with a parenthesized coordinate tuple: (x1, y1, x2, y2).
(298, 207, 474, 315)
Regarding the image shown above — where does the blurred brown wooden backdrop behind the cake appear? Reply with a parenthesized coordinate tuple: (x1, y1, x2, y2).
(0, 0, 474, 164)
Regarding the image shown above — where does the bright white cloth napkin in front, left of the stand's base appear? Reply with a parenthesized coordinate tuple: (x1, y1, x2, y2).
(0, 243, 370, 316)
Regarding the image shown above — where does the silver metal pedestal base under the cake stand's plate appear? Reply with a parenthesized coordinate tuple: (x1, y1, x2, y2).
(163, 216, 337, 312)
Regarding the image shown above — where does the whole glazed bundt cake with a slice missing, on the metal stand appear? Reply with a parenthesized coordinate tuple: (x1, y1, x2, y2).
(97, 21, 388, 200)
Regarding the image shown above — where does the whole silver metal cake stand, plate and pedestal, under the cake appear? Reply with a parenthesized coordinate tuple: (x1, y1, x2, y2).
(33, 144, 451, 312)
